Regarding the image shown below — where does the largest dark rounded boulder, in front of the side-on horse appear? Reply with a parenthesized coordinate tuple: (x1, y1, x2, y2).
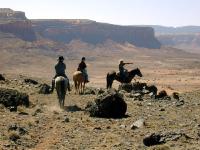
(86, 89, 127, 118)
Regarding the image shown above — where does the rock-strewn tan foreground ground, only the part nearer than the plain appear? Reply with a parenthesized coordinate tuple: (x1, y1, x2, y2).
(0, 76, 200, 150)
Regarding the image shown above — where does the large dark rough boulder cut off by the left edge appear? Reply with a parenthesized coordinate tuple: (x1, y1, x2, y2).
(0, 88, 29, 110)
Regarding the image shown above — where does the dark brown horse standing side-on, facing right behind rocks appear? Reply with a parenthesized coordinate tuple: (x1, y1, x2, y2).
(106, 68, 142, 89)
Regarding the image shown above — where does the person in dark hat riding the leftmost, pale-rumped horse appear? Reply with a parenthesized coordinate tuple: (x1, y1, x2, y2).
(51, 56, 71, 92)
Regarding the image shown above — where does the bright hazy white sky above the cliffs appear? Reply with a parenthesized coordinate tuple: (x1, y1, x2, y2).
(0, 0, 200, 26)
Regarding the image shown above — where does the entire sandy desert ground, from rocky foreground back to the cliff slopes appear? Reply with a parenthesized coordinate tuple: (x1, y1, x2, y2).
(0, 47, 200, 150)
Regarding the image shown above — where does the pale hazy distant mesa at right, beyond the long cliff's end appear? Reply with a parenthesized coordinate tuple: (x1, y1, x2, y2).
(145, 26, 200, 53)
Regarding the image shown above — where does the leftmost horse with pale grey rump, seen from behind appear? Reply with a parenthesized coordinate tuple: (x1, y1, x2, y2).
(55, 76, 69, 108)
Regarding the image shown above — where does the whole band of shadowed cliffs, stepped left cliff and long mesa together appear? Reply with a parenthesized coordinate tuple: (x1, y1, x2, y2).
(0, 8, 161, 48)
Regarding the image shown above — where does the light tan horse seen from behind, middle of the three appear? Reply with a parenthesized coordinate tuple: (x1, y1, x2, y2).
(73, 71, 86, 94)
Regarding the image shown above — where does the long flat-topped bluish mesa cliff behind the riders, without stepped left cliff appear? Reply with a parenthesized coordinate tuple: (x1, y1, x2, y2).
(32, 20, 161, 48)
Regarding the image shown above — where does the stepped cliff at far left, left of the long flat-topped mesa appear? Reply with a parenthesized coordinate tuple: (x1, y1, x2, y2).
(0, 9, 36, 41)
